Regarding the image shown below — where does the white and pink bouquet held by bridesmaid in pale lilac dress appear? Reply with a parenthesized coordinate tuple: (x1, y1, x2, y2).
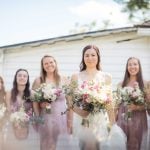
(32, 83, 62, 113)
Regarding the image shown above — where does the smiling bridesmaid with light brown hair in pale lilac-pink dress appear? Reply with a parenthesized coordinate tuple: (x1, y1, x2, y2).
(33, 55, 67, 150)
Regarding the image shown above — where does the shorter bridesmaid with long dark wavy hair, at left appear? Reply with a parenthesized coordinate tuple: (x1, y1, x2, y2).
(4, 69, 38, 150)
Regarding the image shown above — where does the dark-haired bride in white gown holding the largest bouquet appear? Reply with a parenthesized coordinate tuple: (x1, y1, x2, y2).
(68, 45, 126, 150)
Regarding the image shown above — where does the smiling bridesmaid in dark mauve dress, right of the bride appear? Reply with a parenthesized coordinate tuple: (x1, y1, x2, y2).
(117, 57, 147, 150)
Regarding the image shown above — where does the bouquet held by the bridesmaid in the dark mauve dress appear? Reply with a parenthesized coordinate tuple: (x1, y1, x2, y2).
(119, 82, 145, 119)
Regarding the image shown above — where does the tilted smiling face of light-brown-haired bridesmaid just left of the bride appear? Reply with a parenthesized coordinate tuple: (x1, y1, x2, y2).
(43, 57, 56, 73)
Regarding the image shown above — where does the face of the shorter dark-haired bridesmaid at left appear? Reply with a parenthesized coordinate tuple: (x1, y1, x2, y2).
(16, 70, 28, 85)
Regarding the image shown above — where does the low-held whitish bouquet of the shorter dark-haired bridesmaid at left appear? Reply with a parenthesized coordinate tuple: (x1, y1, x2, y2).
(10, 107, 30, 128)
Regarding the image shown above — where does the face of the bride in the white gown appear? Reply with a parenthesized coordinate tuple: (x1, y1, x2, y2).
(84, 48, 98, 68)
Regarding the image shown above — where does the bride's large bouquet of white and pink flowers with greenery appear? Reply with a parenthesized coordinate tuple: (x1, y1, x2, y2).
(63, 81, 111, 113)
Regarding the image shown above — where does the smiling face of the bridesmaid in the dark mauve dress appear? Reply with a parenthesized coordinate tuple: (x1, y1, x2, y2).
(128, 58, 139, 76)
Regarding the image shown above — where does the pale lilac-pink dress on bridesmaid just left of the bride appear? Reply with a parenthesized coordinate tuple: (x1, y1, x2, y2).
(39, 85, 67, 150)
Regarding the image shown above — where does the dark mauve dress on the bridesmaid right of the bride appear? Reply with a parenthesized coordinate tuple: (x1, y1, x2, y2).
(117, 85, 148, 150)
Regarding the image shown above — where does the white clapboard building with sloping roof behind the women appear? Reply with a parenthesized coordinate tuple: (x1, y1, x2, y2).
(0, 21, 150, 89)
